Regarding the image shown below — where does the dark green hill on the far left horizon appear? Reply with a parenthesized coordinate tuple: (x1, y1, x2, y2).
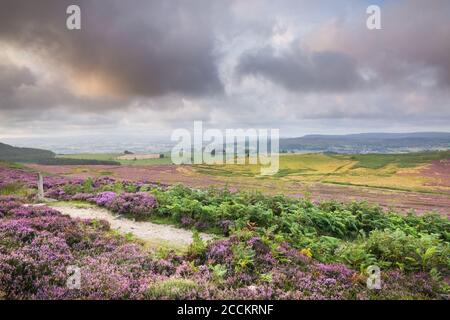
(0, 142, 120, 165)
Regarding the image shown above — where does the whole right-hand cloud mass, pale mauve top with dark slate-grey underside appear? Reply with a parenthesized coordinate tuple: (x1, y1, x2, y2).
(237, 0, 450, 92)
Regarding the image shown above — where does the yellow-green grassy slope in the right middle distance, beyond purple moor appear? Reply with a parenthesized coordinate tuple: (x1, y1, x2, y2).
(194, 151, 450, 192)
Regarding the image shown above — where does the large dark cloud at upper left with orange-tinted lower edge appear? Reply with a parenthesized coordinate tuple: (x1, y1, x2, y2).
(0, 0, 222, 96)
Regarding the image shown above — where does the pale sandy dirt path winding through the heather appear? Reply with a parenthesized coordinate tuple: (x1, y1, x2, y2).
(50, 205, 212, 247)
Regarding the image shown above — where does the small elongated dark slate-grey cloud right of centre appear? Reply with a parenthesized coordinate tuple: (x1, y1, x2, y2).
(237, 47, 364, 92)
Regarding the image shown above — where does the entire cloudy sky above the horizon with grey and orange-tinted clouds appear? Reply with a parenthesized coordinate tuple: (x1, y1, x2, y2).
(0, 0, 450, 139)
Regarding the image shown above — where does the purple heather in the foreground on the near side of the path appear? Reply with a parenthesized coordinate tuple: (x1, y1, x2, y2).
(0, 198, 440, 299)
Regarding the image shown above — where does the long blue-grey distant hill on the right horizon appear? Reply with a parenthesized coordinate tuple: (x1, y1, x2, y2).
(280, 132, 450, 153)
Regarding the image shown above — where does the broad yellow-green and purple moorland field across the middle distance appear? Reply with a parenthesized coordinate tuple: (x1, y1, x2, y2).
(30, 151, 450, 215)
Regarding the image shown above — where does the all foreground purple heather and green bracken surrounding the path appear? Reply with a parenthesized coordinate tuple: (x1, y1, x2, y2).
(0, 168, 450, 299)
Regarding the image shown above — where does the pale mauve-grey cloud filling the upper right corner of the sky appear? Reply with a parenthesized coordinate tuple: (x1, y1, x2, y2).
(307, 0, 450, 90)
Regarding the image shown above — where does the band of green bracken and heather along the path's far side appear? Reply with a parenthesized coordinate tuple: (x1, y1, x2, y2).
(42, 176, 450, 273)
